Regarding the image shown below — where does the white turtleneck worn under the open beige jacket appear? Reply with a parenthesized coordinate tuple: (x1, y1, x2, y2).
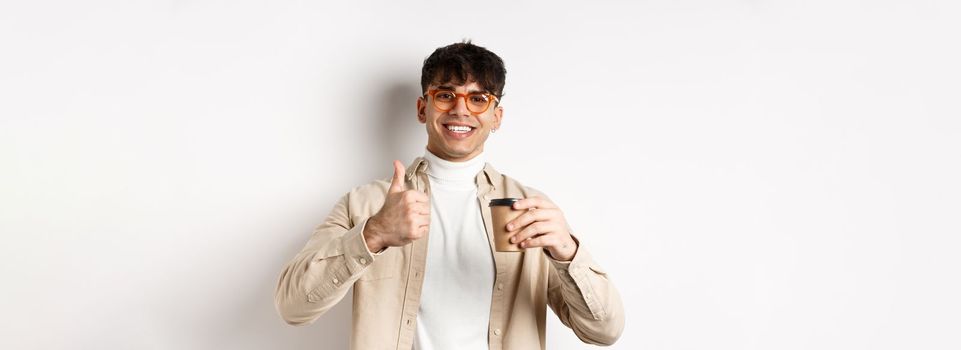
(414, 151, 495, 350)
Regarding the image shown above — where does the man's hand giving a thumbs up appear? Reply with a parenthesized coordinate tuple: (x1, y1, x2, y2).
(364, 160, 430, 253)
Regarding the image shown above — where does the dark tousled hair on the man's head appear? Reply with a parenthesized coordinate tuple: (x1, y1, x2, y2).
(420, 40, 507, 99)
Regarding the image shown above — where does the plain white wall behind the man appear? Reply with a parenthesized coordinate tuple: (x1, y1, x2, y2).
(0, 0, 961, 350)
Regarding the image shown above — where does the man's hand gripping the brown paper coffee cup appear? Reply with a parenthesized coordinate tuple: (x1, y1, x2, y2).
(507, 197, 577, 261)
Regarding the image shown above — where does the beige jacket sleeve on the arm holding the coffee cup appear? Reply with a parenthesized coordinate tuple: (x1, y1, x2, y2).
(545, 242, 624, 345)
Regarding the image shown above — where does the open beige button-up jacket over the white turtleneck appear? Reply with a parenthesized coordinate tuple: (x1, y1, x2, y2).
(275, 157, 624, 350)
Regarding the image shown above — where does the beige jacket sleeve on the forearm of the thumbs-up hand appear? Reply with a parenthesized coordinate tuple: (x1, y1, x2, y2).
(274, 194, 374, 325)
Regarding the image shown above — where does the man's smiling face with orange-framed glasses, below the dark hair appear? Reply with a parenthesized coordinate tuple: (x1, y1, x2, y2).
(417, 82, 504, 162)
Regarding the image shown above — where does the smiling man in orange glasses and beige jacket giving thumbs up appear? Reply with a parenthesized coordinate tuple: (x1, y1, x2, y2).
(275, 41, 624, 350)
